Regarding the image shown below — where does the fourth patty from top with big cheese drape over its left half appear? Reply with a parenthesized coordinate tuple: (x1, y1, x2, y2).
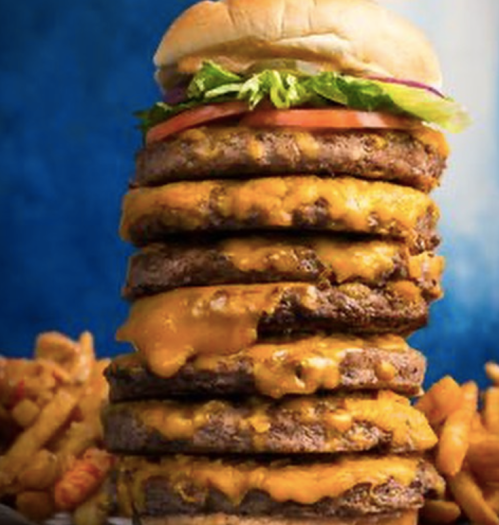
(117, 281, 429, 377)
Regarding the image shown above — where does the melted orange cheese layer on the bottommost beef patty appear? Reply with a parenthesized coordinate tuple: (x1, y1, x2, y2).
(122, 456, 443, 511)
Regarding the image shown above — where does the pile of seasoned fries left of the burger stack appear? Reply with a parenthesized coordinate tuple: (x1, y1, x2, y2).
(0, 332, 112, 525)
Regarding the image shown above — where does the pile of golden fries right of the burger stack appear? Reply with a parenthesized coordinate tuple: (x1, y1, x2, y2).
(416, 363, 499, 525)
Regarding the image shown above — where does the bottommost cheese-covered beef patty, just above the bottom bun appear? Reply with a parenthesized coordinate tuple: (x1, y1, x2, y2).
(117, 455, 444, 519)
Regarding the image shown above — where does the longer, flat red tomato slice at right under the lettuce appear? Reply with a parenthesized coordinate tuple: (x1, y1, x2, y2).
(241, 109, 421, 129)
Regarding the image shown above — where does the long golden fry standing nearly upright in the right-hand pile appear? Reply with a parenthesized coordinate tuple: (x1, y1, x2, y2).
(436, 382, 478, 476)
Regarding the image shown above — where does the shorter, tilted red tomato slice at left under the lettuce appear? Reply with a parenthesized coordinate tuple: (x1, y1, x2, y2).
(146, 102, 249, 144)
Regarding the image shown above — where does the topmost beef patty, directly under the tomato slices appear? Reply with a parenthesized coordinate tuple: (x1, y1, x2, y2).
(135, 126, 447, 191)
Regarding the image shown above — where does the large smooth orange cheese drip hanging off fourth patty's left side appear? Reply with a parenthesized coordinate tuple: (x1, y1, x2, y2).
(117, 284, 314, 377)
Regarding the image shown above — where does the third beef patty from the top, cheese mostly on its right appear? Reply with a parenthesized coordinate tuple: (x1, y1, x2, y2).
(124, 235, 444, 299)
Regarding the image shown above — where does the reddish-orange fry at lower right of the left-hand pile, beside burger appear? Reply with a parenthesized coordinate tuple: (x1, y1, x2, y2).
(54, 449, 113, 510)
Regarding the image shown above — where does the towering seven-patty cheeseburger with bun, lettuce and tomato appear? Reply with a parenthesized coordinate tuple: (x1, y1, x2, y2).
(104, 0, 470, 525)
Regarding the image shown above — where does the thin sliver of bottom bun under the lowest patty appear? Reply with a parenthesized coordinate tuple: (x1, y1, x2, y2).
(140, 510, 418, 525)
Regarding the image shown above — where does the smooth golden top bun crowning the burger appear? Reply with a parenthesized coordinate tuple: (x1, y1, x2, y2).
(154, 0, 442, 88)
